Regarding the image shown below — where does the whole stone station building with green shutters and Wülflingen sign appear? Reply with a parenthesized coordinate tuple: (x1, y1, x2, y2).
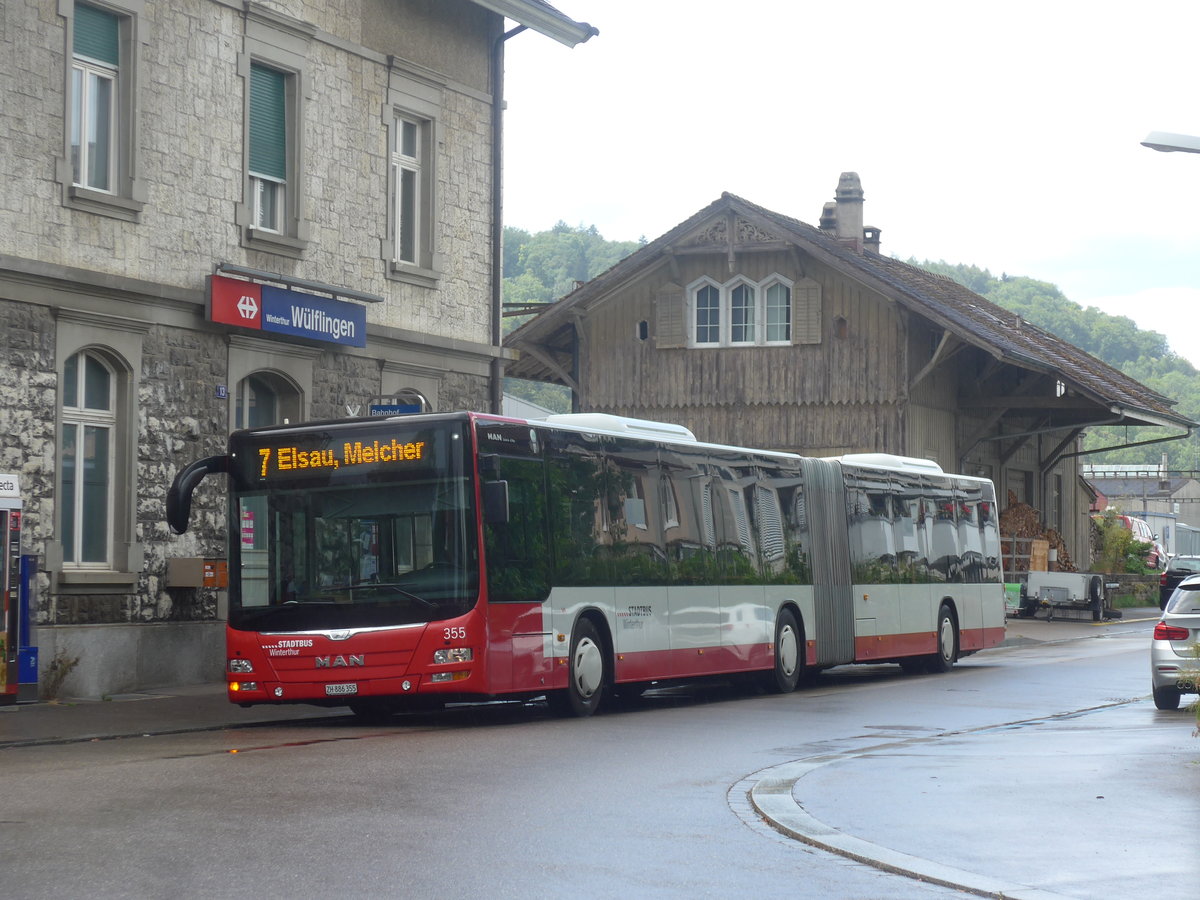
(0, 0, 596, 696)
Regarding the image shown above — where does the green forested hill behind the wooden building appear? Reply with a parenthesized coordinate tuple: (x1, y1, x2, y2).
(504, 222, 1200, 469)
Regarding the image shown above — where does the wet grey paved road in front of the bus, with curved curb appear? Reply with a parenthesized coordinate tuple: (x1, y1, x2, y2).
(0, 617, 1200, 900)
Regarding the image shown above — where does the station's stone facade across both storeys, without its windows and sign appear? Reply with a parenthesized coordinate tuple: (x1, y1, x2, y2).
(0, 0, 503, 696)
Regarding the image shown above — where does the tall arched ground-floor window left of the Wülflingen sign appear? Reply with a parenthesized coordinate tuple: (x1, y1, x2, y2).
(59, 350, 118, 568)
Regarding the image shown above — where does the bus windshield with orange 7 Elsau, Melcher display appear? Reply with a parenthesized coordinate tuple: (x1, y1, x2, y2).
(229, 424, 479, 631)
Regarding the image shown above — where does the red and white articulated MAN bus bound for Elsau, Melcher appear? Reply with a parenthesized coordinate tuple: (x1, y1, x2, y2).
(167, 413, 1004, 715)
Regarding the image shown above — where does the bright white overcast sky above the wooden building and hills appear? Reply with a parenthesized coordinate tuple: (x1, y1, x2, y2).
(504, 0, 1200, 365)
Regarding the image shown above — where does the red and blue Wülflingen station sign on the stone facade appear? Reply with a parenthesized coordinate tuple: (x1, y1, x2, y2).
(209, 275, 367, 347)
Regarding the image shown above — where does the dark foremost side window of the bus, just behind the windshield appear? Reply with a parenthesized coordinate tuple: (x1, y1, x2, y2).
(484, 458, 550, 602)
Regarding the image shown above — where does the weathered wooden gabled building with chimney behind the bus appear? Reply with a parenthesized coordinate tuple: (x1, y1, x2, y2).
(505, 173, 1194, 571)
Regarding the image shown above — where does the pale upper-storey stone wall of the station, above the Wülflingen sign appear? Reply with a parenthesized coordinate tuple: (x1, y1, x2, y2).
(0, 0, 493, 343)
